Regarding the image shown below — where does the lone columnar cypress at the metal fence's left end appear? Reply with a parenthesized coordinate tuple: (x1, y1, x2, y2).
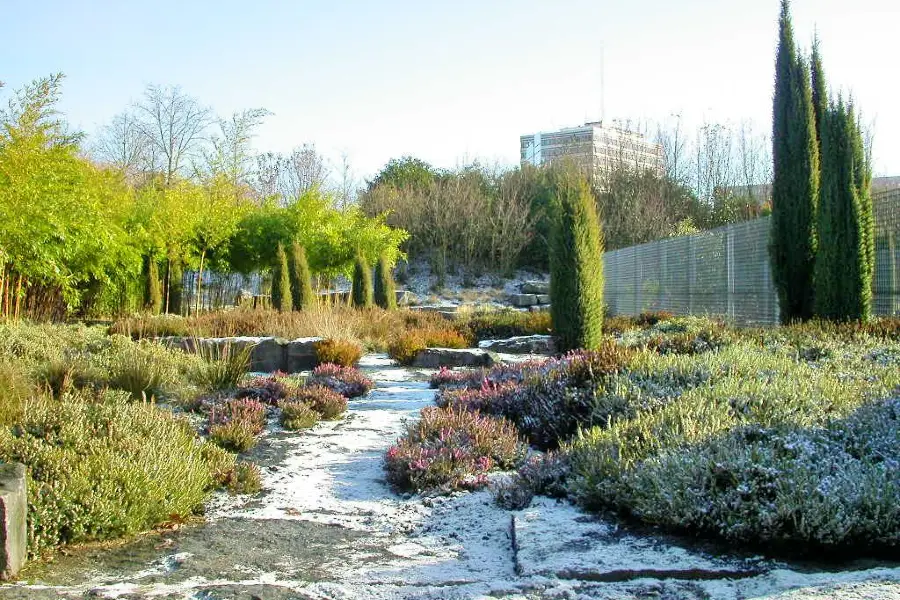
(550, 167, 603, 352)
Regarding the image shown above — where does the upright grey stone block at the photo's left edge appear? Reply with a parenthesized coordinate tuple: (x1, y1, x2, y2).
(0, 463, 28, 580)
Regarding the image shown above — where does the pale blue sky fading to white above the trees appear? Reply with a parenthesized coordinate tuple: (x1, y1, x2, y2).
(0, 0, 900, 181)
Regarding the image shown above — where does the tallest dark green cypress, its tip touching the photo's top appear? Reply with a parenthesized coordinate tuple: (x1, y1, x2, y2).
(769, 0, 819, 323)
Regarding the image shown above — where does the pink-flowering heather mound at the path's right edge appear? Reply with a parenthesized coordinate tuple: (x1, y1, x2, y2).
(385, 407, 524, 491)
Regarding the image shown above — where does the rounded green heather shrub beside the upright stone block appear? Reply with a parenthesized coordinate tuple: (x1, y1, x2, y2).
(0, 390, 221, 557)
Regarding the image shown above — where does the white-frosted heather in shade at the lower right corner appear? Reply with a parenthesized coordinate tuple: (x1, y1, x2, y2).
(616, 400, 900, 550)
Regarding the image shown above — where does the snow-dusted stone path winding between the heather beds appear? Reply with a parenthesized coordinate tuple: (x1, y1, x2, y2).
(0, 356, 900, 600)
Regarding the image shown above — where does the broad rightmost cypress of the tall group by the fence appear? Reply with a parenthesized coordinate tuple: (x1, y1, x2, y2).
(815, 101, 875, 321)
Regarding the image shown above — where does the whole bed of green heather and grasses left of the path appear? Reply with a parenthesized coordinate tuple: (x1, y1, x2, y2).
(0, 323, 266, 557)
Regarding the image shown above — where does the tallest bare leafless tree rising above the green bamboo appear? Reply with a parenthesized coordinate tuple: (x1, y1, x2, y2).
(135, 85, 211, 183)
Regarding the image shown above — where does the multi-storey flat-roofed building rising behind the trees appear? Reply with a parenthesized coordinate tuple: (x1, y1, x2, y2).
(520, 123, 665, 179)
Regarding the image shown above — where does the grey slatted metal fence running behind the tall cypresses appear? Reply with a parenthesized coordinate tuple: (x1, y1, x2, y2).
(603, 190, 900, 324)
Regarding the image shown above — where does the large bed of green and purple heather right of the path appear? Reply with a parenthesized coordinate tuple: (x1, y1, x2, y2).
(389, 315, 900, 552)
